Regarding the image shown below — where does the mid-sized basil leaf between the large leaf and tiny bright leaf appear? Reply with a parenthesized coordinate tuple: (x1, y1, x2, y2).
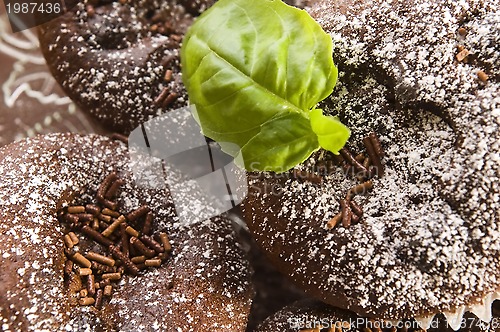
(235, 113, 319, 173)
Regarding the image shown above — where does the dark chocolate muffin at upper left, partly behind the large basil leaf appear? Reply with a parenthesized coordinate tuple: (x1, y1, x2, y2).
(39, 0, 212, 134)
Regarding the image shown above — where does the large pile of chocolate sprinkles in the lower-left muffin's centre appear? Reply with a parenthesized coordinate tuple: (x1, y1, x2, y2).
(59, 173, 171, 309)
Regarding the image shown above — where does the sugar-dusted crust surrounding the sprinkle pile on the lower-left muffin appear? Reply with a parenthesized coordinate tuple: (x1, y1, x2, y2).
(0, 134, 253, 331)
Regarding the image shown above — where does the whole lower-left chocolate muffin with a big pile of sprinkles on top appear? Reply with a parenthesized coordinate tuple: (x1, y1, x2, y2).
(0, 134, 253, 331)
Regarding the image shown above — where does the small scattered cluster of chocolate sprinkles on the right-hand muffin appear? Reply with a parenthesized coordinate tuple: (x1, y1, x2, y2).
(326, 132, 384, 229)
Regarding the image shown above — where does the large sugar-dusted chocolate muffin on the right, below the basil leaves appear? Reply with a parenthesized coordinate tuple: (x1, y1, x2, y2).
(240, 0, 500, 320)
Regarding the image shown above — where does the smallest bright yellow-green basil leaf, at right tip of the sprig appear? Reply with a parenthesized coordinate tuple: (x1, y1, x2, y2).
(309, 109, 351, 154)
